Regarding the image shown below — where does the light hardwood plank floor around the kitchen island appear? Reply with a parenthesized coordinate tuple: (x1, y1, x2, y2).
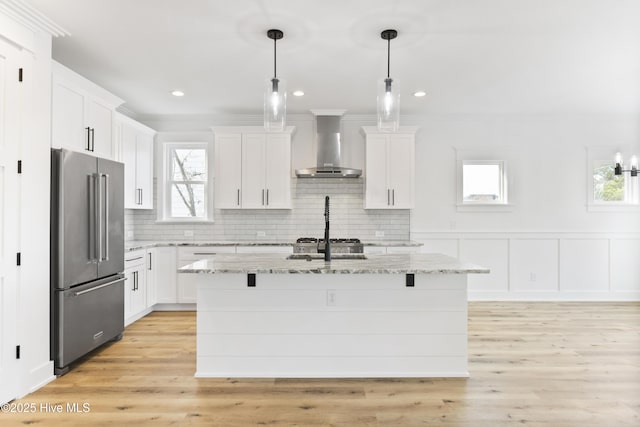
(0, 302, 640, 427)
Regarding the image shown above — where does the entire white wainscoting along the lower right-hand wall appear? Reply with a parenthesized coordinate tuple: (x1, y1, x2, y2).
(411, 230, 640, 301)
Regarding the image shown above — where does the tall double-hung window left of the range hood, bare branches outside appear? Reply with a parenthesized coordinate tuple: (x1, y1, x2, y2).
(159, 143, 212, 221)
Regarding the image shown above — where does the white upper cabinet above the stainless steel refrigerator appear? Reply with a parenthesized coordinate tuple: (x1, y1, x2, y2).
(51, 61, 123, 158)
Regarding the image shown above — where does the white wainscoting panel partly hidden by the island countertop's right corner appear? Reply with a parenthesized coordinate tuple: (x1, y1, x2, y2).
(460, 239, 509, 292)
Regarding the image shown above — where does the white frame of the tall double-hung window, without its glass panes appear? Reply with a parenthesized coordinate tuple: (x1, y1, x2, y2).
(157, 141, 214, 223)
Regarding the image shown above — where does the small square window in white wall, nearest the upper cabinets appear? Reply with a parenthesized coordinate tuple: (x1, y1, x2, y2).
(462, 160, 507, 205)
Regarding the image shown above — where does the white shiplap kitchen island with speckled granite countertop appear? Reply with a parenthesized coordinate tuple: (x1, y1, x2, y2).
(179, 254, 489, 378)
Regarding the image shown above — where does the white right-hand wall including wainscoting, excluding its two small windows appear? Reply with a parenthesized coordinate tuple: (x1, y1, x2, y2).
(406, 115, 640, 300)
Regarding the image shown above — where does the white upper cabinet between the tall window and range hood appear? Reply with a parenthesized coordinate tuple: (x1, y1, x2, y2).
(214, 126, 295, 209)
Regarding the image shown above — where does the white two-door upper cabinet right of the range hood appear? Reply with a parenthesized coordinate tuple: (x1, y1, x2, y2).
(362, 126, 417, 209)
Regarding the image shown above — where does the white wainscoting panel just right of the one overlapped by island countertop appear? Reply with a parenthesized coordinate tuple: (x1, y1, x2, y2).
(509, 239, 558, 292)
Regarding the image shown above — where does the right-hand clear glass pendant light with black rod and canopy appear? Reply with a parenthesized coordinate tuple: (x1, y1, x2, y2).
(377, 30, 400, 132)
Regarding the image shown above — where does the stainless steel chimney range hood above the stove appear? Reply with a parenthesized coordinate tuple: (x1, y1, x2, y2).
(296, 111, 362, 178)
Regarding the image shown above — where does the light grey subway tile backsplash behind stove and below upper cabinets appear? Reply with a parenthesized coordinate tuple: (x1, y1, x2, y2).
(125, 178, 411, 242)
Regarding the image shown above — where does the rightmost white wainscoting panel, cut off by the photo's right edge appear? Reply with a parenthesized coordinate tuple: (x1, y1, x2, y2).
(611, 239, 640, 292)
